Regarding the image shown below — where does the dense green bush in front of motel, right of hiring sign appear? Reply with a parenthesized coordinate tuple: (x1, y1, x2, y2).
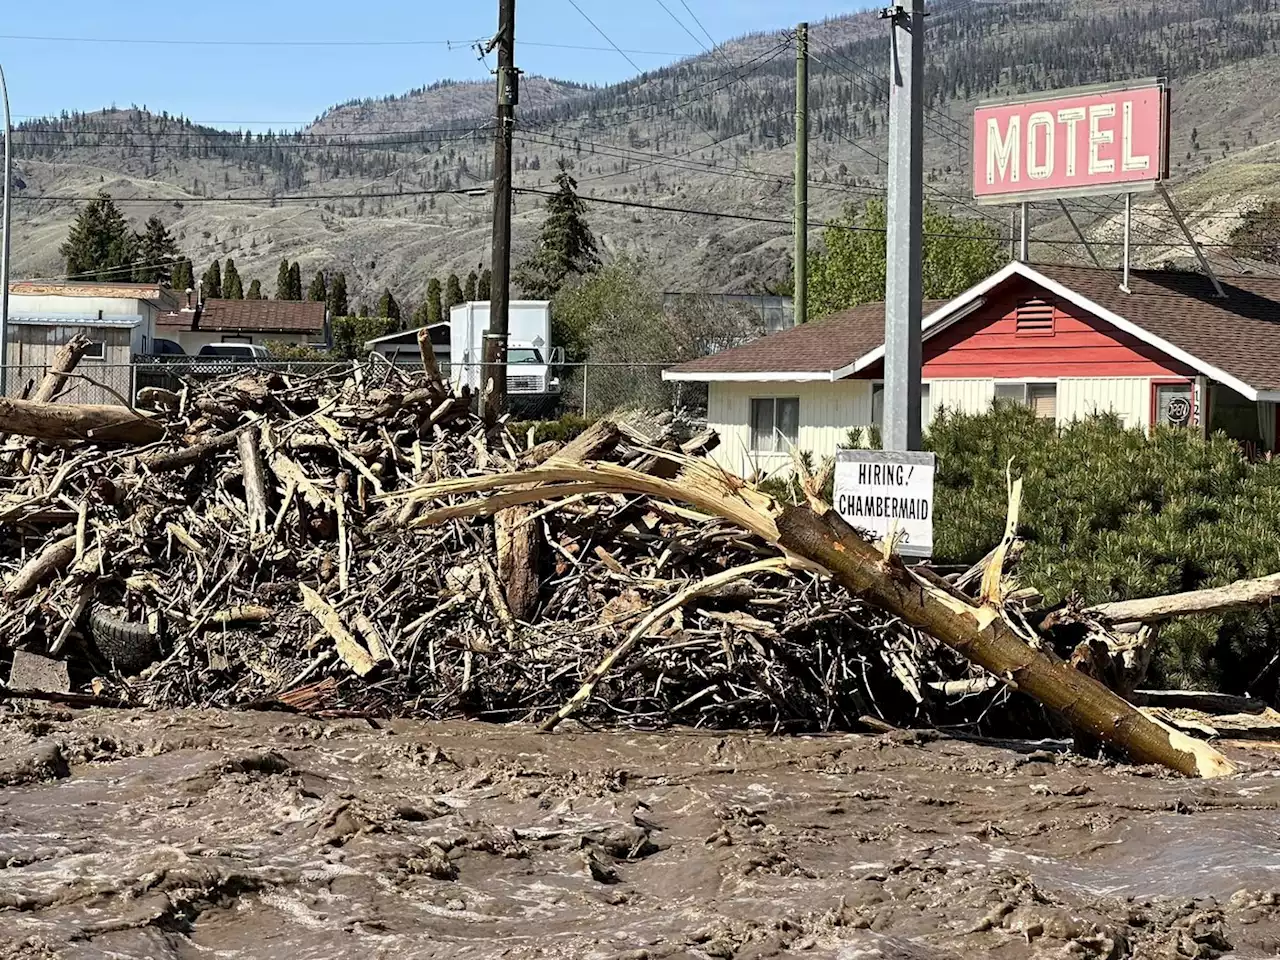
(925, 403, 1280, 691)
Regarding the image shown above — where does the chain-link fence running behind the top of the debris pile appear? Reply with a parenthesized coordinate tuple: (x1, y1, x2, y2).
(5, 356, 707, 419)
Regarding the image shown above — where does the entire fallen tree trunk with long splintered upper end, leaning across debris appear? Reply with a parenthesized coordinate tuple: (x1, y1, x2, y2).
(394, 454, 1235, 777)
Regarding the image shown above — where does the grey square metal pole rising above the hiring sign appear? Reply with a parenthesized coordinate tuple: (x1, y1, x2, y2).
(881, 0, 924, 451)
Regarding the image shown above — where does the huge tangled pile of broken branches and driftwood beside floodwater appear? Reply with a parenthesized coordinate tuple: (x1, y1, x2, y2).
(0, 364, 962, 730)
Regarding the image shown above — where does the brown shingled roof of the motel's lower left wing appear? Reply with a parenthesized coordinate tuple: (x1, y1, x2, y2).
(669, 300, 945, 374)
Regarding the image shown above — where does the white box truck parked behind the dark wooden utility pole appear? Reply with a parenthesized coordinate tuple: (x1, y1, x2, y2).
(449, 300, 564, 399)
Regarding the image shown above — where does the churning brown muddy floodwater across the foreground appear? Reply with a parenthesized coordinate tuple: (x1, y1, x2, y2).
(0, 708, 1280, 960)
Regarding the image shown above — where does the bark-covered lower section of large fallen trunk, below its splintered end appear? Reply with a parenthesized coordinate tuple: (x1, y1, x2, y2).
(777, 507, 1235, 777)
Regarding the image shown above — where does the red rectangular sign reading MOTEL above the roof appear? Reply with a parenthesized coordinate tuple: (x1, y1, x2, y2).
(973, 81, 1169, 204)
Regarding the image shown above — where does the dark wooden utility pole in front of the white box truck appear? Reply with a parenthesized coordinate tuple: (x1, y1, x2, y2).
(480, 0, 520, 421)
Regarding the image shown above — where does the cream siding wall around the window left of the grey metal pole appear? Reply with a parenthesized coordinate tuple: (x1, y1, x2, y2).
(707, 380, 872, 476)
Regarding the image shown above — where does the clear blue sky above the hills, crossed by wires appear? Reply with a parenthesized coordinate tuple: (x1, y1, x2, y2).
(0, 0, 865, 129)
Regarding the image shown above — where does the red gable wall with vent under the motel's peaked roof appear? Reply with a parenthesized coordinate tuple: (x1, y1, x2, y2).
(861, 282, 1196, 380)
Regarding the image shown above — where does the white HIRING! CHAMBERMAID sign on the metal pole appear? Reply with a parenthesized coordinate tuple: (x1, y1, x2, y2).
(835, 451, 934, 557)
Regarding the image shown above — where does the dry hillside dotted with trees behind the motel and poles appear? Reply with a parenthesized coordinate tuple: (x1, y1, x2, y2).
(7, 0, 1280, 305)
